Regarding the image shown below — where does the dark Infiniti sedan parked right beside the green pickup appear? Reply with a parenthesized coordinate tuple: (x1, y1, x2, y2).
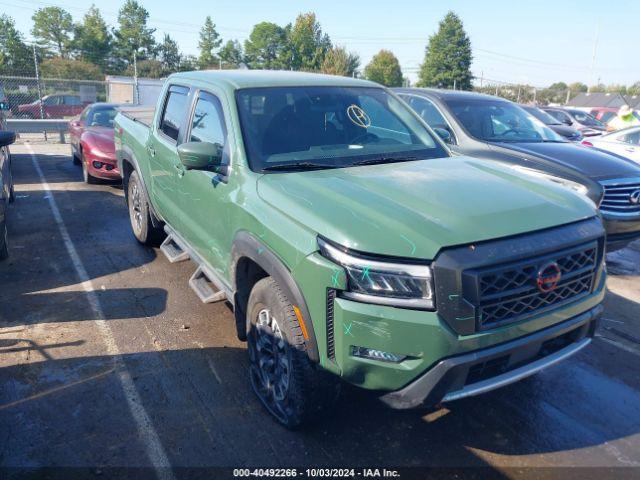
(395, 88, 640, 249)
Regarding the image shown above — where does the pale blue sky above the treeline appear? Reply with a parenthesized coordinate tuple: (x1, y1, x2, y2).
(0, 0, 640, 87)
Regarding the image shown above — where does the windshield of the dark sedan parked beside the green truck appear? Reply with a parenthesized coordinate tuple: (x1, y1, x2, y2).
(445, 100, 565, 142)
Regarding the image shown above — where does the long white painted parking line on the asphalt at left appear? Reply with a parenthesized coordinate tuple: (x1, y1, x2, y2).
(25, 144, 174, 480)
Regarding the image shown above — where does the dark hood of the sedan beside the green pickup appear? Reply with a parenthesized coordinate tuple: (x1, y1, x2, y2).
(490, 142, 640, 180)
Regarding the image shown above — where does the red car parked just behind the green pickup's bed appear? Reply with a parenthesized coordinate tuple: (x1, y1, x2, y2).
(69, 103, 122, 183)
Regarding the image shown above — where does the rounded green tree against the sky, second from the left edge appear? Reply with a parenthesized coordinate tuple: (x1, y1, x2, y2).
(31, 7, 73, 58)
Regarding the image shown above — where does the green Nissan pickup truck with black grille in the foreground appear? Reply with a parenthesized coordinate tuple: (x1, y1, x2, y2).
(115, 71, 605, 427)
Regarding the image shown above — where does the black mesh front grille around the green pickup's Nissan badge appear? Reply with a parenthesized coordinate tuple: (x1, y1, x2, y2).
(470, 242, 598, 330)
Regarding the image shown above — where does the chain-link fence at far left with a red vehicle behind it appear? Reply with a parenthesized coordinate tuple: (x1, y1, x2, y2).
(0, 75, 107, 119)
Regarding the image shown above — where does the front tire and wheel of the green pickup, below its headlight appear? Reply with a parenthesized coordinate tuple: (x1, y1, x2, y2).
(247, 277, 339, 429)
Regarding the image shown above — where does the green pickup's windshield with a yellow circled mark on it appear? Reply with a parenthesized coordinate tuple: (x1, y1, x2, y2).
(236, 87, 449, 171)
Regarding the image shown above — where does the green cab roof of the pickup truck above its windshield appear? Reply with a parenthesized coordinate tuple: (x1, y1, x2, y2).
(168, 70, 380, 90)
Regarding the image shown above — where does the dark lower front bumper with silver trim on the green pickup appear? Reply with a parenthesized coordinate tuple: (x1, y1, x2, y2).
(381, 305, 602, 409)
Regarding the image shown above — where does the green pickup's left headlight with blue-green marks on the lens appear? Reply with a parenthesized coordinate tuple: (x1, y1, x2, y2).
(318, 238, 435, 310)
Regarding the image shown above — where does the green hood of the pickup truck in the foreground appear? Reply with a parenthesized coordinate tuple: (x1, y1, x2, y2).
(258, 157, 595, 259)
